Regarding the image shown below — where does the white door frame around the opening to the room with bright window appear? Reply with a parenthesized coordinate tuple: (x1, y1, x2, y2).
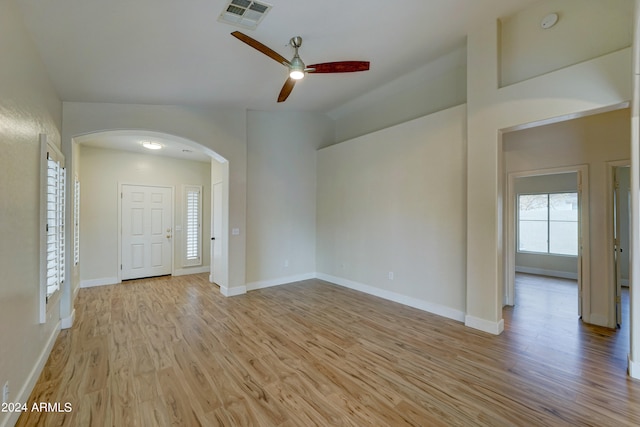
(503, 165, 591, 322)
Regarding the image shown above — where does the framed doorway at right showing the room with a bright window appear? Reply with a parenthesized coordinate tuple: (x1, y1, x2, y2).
(504, 165, 589, 317)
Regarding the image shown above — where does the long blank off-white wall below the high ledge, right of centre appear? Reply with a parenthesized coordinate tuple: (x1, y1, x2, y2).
(316, 106, 466, 320)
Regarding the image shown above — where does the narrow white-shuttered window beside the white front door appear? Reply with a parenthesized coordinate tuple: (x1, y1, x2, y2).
(183, 185, 202, 267)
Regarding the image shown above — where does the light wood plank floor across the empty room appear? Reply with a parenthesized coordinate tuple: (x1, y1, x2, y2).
(18, 275, 640, 426)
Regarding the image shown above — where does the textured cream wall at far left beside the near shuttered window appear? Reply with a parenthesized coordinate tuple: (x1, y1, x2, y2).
(0, 0, 62, 426)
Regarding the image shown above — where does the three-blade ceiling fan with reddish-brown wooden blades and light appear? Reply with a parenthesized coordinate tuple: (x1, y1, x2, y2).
(231, 31, 369, 102)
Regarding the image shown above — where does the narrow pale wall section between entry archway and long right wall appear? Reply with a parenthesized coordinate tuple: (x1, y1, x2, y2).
(247, 111, 333, 290)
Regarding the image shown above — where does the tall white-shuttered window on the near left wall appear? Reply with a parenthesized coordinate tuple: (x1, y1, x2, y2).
(40, 135, 66, 322)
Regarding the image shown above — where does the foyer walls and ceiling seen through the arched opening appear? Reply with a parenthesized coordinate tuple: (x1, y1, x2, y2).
(67, 130, 229, 294)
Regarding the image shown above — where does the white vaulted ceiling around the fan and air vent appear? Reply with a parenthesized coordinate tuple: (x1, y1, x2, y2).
(17, 0, 533, 157)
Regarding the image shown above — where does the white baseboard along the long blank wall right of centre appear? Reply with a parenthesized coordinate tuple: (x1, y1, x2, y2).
(316, 273, 464, 322)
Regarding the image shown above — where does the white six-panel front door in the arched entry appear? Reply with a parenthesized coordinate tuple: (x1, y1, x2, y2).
(121, 185, 173, 280)
